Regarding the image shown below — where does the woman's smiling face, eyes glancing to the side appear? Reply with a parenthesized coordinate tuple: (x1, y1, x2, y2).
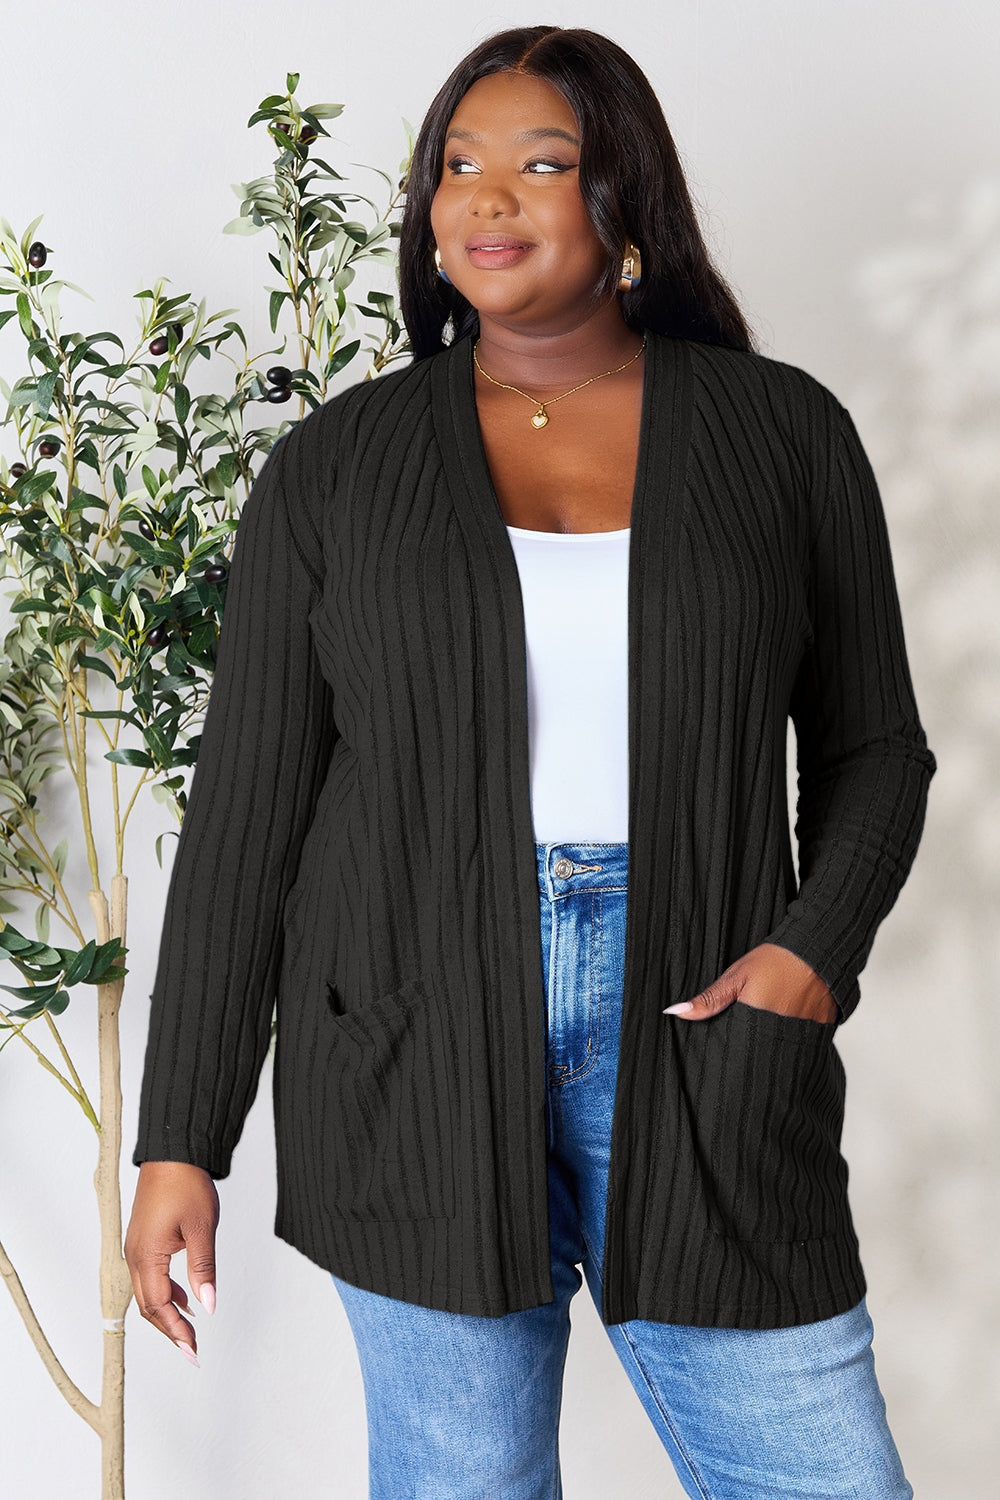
(430, 72, 613, 329)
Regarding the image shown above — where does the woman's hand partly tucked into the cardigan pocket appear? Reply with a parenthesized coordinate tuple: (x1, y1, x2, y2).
(664, 942, 838, 1025)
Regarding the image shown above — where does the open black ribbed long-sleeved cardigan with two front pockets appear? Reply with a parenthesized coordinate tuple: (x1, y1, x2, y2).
(132, 333, 934, 1328)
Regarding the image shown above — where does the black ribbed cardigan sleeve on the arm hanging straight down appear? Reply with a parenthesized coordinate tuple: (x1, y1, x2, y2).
(132, 423, 336, 1178)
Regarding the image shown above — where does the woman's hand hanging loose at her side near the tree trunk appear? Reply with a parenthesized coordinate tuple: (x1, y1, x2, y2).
(124, 1161, 219, 1364)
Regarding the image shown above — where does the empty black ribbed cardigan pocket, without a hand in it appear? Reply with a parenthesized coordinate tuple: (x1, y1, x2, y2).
(324, 975, 456, 1220)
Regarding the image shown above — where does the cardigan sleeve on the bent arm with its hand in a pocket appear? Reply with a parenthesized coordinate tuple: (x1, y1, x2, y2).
(766, 402, 936, 1019)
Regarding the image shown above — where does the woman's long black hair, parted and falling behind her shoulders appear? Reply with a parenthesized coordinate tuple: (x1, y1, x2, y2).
(399, 26, 756, 360)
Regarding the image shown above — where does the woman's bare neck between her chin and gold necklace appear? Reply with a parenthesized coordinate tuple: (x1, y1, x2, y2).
(478, 297, 642, 395)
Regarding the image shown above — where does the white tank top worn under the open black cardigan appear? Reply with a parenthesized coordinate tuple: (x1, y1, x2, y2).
(507, 527, 630, 843)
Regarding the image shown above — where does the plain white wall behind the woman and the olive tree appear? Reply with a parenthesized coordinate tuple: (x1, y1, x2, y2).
(0, 0, 1000, 1500)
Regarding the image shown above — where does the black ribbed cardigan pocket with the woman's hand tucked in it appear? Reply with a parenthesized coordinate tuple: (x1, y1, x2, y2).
(702, 1001, 850, 1242)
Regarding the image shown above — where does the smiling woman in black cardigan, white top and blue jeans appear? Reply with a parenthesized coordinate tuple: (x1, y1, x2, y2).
(126, 27, 934, 1500)
